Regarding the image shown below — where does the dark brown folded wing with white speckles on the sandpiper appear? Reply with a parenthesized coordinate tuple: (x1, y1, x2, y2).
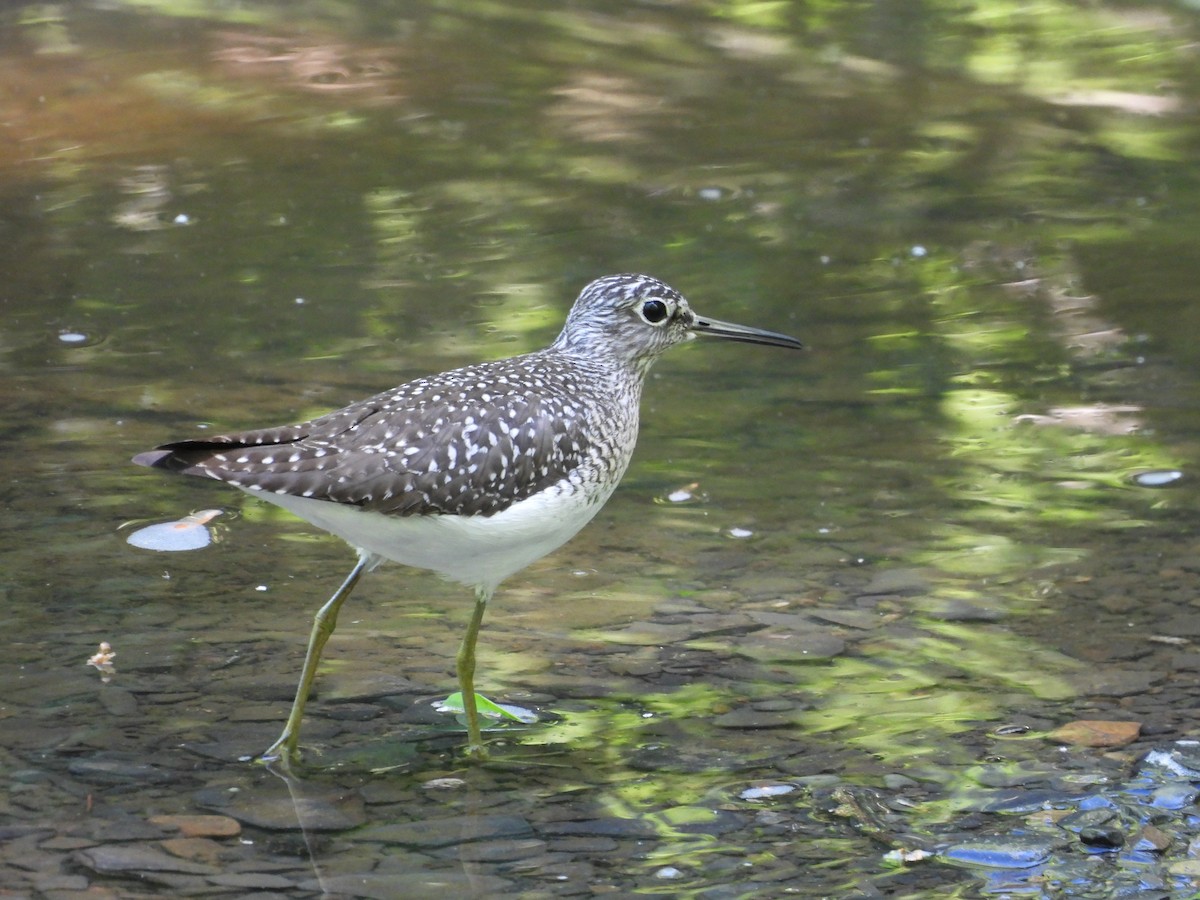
(134, 354, 594, 516)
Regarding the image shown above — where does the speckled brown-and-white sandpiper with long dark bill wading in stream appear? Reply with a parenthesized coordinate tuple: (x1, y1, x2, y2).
(133, 275, 800, 764)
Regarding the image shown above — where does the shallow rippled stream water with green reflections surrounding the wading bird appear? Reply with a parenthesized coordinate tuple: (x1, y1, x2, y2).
(0, 2, 1200, 898)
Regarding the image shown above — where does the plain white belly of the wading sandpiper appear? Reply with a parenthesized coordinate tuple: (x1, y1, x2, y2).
(246, 488, 612, 593)
